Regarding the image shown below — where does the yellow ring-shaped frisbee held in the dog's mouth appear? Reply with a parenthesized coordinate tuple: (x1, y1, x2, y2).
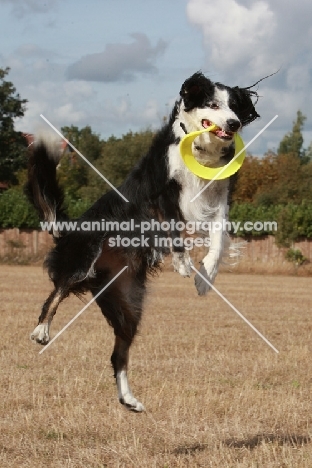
(180, 124, 246, 180)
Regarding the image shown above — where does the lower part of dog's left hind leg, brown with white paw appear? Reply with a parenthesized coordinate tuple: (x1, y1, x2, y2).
(30, 289, 66, 345)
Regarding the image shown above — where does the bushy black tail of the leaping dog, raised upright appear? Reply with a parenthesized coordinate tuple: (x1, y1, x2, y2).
(25, 135, 68, 238)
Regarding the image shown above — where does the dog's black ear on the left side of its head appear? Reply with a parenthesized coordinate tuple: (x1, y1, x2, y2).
(180, 72, 213, 112)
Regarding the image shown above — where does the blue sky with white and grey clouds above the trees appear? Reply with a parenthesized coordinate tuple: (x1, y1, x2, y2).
(0, 0, 312, 156)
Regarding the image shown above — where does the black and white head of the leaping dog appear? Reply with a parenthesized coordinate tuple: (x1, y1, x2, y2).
(180, 72, 259, 162)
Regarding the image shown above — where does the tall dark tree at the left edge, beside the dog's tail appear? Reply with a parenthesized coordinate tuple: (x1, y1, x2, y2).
(0, 68, 27, 183)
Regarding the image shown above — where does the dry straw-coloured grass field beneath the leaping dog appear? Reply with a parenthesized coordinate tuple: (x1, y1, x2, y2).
(0, 266, 312, 468)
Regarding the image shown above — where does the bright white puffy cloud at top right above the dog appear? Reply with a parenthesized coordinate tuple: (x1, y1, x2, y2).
(187, 0, 276, 76)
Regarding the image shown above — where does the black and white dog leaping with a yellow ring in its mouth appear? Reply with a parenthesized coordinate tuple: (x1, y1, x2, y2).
(27, 72, 259, 411)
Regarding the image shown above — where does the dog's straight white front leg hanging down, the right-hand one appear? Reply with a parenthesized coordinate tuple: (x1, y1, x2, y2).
(195, 210, 226, 296)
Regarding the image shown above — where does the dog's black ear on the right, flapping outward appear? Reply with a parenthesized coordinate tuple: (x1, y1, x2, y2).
(230, 86, 260, 127)
